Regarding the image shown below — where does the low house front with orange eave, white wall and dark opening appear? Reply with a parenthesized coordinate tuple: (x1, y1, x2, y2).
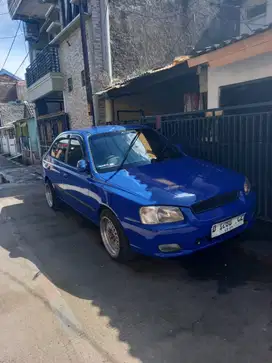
(188, 25, 272, 109)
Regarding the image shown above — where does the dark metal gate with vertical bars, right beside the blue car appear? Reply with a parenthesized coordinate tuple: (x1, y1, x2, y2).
(121, 111, 272, 221)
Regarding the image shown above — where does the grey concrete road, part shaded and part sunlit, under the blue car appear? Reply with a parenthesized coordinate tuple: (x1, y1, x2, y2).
(0, 183, 272, 363)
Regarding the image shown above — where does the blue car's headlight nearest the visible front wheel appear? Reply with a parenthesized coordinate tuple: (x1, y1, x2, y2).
(140, 207, 184, 224)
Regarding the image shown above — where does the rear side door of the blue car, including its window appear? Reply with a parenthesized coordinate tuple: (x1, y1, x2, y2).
(43, 135, 69, 199)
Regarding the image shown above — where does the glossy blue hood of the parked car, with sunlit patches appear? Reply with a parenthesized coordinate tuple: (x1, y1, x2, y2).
(100, 156, 244, 207)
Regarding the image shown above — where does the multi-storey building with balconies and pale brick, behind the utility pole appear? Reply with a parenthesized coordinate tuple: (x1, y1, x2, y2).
(8, 0, 111, 134)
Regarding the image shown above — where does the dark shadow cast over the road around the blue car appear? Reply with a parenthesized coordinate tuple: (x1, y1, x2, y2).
(0, 188, 272, 363)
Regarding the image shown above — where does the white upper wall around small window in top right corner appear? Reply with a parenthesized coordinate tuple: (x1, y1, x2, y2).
(240, 0, 272, 34)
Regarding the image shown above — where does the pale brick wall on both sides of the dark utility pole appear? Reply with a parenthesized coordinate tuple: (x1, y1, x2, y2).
(59, 0, 109, 129)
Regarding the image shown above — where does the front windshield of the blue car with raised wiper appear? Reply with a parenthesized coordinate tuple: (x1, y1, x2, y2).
(90, 128, 182, 173)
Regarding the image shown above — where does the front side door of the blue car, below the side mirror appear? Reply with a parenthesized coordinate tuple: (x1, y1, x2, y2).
(60, 135, 98, 219)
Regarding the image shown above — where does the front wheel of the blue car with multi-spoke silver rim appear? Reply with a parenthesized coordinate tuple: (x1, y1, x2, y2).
(100, 210, 134, 263)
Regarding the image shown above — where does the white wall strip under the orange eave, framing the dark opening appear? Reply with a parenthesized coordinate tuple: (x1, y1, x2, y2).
(208, 53, 272, 108)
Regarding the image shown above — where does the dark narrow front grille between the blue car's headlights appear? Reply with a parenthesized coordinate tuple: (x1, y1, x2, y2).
(191, 191, 239, 214)
